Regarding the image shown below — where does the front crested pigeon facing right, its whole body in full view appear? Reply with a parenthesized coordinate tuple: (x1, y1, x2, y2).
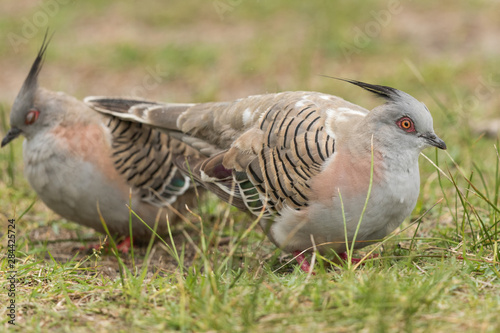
(84, 80, 446, 270)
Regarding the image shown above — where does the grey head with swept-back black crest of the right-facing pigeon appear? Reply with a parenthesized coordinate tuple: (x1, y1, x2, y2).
(342, 79, 446, 152)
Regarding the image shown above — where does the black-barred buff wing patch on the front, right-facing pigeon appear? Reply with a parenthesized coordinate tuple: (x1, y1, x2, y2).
(246, 98, 335, 214)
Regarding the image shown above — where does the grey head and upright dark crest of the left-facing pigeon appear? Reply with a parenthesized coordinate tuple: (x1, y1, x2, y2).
(2, 33, 55, 147)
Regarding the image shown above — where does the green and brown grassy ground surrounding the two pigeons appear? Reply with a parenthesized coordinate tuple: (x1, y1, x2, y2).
(0, 0, 500, 332)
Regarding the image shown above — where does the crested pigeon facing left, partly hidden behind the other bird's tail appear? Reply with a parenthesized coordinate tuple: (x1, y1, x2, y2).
(1, 36, 201, 246)
